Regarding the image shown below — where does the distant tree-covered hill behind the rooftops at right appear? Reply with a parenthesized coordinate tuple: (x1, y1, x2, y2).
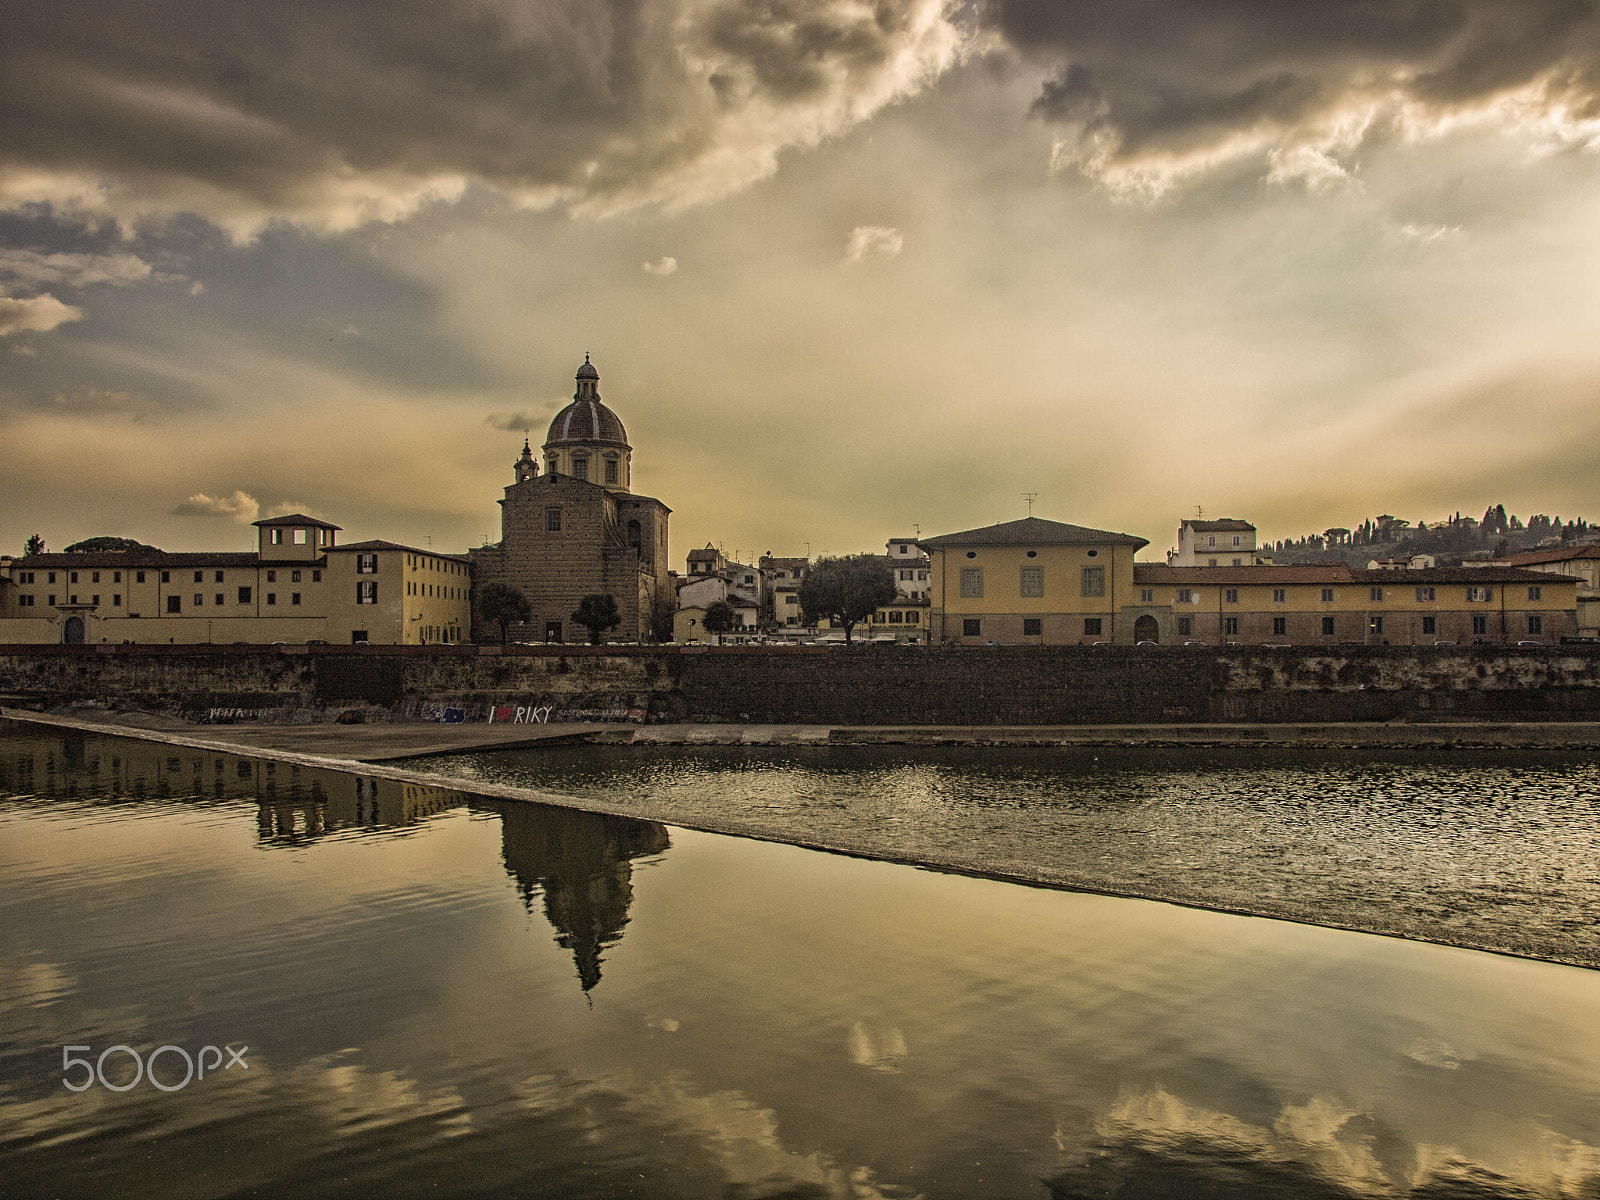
(1264, 504, 1600, 566)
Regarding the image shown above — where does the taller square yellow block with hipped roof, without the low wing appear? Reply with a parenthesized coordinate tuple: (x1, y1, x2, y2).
(917, 517, 1149, 645)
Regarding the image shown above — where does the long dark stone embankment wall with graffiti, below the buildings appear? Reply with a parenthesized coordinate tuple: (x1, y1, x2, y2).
(0, 646, 1600, 725)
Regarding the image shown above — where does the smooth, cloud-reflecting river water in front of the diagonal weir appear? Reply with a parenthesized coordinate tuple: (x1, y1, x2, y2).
(0, 728, 1600, 1200)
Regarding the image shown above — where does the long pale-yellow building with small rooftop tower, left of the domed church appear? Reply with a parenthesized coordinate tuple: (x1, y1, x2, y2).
(0, 514, 470, 645)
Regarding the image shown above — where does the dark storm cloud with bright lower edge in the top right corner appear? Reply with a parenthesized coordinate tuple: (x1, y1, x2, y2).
(987, 0, 1600, 188)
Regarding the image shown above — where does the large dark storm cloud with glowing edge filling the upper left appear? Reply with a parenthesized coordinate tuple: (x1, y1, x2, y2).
(0, 0, 958, 229)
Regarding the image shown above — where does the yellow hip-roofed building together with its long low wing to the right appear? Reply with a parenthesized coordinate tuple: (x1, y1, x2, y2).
(918, 517, 1579, 645)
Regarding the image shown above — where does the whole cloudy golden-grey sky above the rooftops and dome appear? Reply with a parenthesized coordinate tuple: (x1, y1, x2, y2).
(0, 0, 1600, 565)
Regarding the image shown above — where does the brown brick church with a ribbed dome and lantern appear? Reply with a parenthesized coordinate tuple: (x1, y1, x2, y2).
(469, 355, 674, 642)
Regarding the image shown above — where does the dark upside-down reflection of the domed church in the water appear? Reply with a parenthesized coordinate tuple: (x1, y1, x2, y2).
(501, 803, 670, 992)
